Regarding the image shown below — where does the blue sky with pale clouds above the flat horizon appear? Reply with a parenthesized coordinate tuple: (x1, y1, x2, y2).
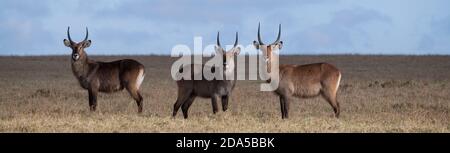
(0, 0, 450, 55)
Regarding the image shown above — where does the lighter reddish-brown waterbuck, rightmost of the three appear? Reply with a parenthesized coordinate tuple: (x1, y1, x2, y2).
(253, 24, 341, 119)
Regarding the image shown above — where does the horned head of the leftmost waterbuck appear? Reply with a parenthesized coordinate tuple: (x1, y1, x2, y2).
(64, 27, 91, 62)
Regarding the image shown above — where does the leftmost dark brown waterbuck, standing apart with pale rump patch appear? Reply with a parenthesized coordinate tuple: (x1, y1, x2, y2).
(64, 27, 145, 113)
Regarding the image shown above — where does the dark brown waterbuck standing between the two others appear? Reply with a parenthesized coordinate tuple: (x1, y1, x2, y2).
(173, 32, 241, 119)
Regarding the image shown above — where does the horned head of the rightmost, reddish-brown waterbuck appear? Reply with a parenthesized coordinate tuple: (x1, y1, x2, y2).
(253, 24, 283, 72)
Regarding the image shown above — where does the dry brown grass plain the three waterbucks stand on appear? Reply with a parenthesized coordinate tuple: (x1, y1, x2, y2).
(0, 56, 450, 132)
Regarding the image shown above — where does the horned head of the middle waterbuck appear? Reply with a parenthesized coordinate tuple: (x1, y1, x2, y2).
(215, 32, 241, 72)
